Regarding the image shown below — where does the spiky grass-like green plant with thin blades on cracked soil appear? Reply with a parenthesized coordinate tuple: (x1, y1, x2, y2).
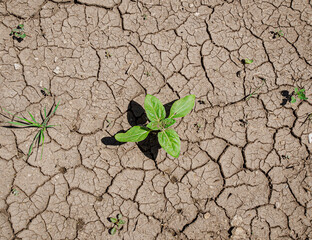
(3, 102, 60, 159)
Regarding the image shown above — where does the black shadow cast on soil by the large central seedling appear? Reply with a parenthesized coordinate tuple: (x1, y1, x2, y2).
(101, 101, 174, 160)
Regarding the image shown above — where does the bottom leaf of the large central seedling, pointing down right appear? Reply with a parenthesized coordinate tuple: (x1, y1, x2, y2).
(158, 128, 181, 158)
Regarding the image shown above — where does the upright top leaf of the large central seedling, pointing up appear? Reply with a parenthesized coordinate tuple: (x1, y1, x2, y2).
(144, 94, 166, 122)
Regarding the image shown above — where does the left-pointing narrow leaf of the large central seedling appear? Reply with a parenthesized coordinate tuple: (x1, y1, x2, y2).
(115, 126, 150, 142)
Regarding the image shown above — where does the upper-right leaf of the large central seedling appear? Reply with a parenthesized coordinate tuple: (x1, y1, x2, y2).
(169, 94, 195, 118)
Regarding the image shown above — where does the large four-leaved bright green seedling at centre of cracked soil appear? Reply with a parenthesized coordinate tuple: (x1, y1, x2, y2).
(115, 94, 195, 158)
